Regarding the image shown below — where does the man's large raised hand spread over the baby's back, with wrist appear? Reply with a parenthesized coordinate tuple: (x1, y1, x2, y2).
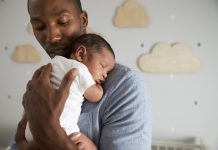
(23, 64, 78, 149)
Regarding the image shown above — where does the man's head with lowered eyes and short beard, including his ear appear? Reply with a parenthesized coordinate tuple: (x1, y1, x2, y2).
(28, 0, 88, 58)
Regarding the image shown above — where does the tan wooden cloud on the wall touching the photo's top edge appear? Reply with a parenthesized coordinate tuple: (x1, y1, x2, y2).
(114, 0, 149, 27)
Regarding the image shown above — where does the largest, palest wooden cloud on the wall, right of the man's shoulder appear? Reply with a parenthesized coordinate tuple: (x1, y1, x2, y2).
(138, 43, 201, 73)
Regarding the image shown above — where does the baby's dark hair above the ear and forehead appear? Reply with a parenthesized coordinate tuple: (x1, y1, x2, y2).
(71, 33, 115, 58)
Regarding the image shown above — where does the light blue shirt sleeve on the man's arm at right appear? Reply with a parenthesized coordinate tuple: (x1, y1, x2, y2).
(99, 71, 152, 150)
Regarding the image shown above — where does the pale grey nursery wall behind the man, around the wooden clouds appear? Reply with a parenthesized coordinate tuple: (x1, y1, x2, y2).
(0, 0, 218, 149)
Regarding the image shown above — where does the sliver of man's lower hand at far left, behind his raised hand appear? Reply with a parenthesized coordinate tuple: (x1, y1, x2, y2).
(15, 114, 27, 144)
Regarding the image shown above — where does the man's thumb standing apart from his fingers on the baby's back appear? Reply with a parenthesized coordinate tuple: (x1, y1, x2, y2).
(59, 68, 79, 92)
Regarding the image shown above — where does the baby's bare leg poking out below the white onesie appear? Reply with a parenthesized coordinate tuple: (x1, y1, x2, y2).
(70, 132, 97, 150)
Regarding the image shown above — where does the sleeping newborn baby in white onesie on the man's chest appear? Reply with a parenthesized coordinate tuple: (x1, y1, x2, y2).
(25, 34, 115, 150)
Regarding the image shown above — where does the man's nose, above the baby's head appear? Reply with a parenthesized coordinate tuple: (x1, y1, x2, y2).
(46, 25, 62, 43)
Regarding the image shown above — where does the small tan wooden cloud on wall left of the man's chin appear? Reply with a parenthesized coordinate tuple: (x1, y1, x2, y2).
(12, 44, 41, 63)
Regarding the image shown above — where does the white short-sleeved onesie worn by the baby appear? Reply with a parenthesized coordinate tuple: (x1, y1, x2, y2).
(51, 56, 95, 135)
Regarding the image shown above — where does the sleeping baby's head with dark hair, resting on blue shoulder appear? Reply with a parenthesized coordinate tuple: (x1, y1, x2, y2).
(70, 33, 115, 84)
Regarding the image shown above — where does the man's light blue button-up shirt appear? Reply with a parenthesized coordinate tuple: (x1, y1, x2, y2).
(11, 64, 152, 150)
